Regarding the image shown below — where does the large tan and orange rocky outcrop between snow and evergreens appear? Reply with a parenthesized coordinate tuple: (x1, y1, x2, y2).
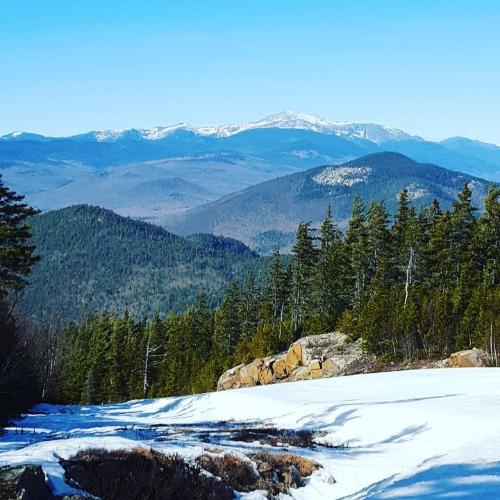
(217, 332, 375, 391)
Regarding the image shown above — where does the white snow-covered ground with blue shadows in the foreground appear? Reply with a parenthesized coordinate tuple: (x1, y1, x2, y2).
(0, 368, 500, 499)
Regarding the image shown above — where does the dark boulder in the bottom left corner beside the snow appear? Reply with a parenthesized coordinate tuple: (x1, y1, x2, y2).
(0, 465, 55, 500)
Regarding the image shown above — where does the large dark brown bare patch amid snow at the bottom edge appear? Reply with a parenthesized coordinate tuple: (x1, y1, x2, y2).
(60, 449, 234, 500)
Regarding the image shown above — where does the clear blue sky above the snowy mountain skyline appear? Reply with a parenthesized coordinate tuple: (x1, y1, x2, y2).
(0, 0, 500, 144)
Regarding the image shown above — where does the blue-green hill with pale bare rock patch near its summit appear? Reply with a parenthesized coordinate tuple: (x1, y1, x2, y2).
(165, 153, 488, 249)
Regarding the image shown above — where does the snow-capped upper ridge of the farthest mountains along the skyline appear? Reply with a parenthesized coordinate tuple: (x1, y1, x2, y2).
(1, 111, 423, 144)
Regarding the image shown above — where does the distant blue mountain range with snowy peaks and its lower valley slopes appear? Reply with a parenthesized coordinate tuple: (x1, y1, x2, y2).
(0, 112, 500, 222)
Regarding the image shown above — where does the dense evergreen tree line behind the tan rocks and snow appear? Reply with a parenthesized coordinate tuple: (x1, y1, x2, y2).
(44, 185, 500, 403)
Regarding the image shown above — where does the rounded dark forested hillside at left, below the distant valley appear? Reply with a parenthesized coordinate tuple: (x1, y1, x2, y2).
(19, 205, 262, 320)
